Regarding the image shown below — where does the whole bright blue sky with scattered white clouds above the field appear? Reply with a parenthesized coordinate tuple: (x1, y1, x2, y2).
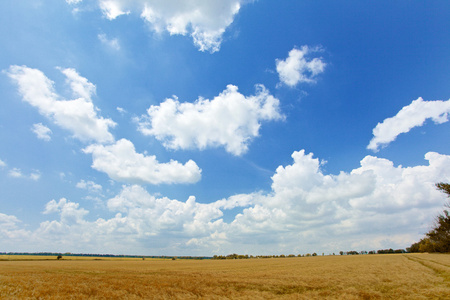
(0, 0, 450, 256)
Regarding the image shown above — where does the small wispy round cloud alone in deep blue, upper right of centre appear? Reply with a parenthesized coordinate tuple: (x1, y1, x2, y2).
(276, 46, 326, 87)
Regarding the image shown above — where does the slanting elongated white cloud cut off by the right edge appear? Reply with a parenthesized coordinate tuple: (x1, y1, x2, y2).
(367, 98, 450, 151)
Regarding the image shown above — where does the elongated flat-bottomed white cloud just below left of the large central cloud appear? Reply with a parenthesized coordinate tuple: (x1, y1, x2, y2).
(83, 139, 201, 184)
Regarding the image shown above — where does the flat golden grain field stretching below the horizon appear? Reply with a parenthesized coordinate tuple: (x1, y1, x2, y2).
(0, 254, 450, 299)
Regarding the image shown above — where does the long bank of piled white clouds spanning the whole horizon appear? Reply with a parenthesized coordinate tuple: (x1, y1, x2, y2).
(0, 150, 450, 255)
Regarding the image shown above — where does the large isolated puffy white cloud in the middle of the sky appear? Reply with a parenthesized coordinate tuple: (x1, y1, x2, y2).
(138, 85, 284, 155)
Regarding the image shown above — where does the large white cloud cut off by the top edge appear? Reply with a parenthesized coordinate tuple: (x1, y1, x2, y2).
(89, 0, 246, 52)
